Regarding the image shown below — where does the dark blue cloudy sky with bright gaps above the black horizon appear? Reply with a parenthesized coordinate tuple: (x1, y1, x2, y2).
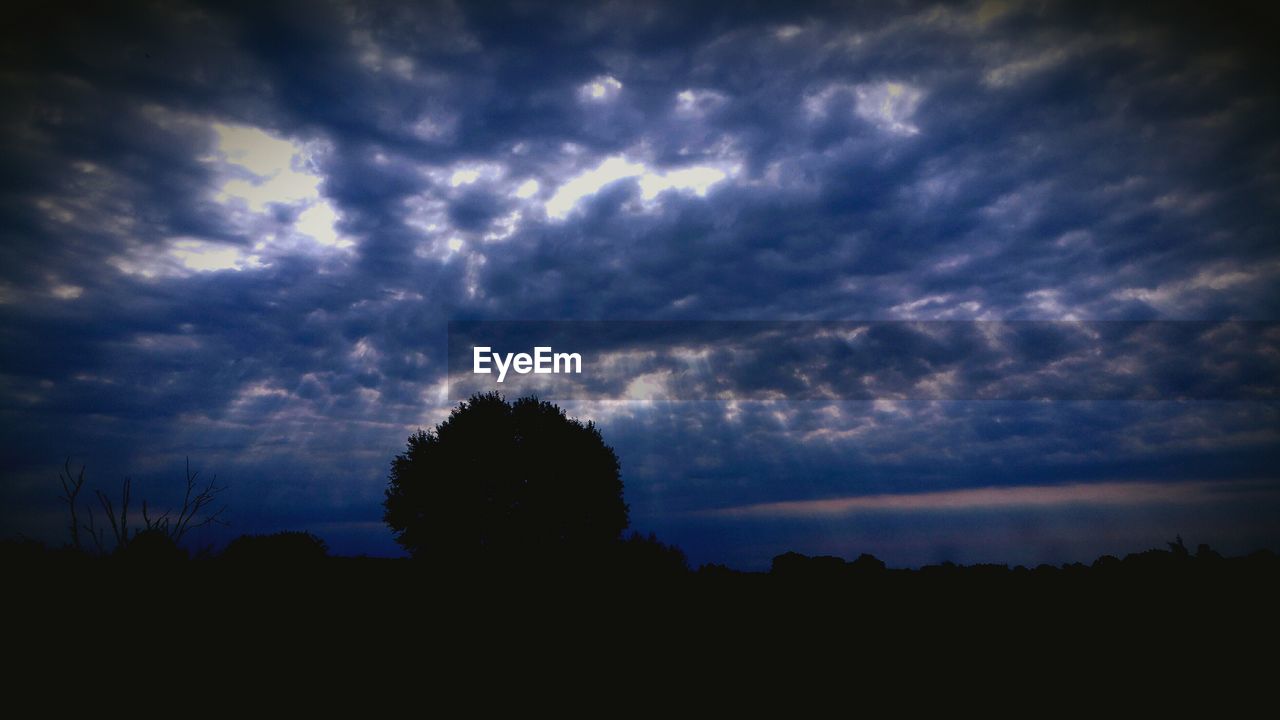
(0, 0, 1280, 568)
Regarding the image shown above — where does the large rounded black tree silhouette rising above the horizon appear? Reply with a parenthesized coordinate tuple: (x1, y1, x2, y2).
(384, 393, 627, 566)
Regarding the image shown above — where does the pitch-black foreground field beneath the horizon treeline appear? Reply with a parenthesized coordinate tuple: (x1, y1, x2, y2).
(5, 551, 1280, 717)
